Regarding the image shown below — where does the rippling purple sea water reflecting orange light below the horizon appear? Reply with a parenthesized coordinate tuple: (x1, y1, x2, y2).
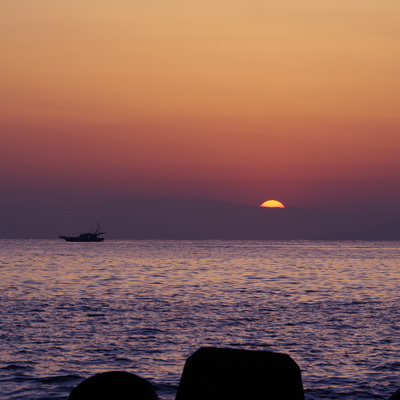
(0, 240, 400, 400)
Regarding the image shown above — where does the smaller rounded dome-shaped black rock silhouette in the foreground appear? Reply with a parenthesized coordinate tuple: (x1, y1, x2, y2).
(68, 371, 158, 400)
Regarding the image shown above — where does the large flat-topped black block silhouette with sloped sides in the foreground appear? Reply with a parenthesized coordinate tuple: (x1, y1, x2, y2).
(176, 347, 304, 400)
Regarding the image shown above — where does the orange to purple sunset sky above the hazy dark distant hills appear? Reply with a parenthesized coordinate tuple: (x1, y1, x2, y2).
(0, 0, 400, 208)
